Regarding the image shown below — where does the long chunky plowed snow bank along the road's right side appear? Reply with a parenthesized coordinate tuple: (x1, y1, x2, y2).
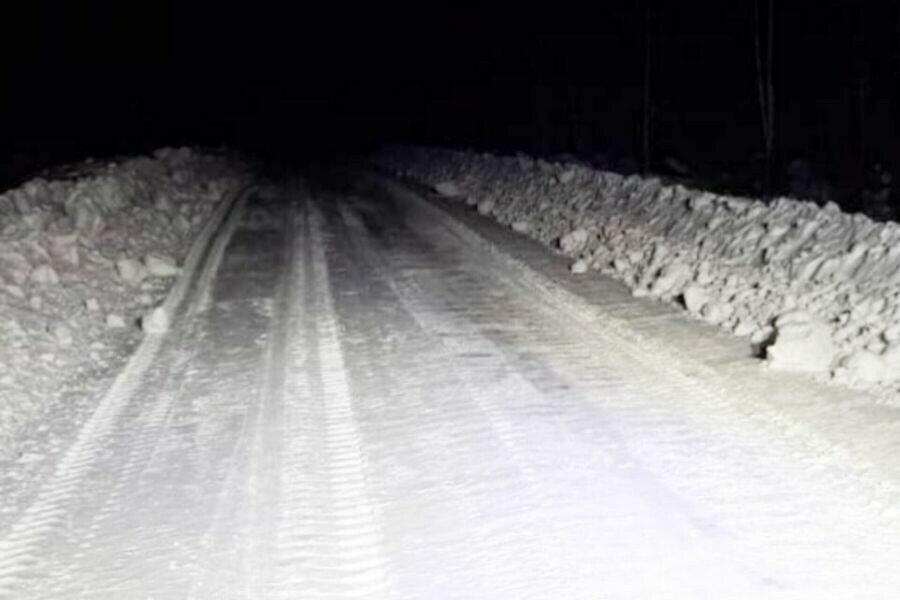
(377, 148, 900, 385)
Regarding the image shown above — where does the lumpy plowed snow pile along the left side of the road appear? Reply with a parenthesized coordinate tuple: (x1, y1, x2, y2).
(0, 148, 247, 458)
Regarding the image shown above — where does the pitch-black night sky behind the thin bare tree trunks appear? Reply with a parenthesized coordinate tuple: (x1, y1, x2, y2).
(0, 0, 900, 198)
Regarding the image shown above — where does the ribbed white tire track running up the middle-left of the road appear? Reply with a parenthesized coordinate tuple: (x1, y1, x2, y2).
(273, 199, 390, 598)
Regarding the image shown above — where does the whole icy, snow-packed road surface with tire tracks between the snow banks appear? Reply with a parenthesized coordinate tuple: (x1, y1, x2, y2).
(0, 171, 900, 600)
